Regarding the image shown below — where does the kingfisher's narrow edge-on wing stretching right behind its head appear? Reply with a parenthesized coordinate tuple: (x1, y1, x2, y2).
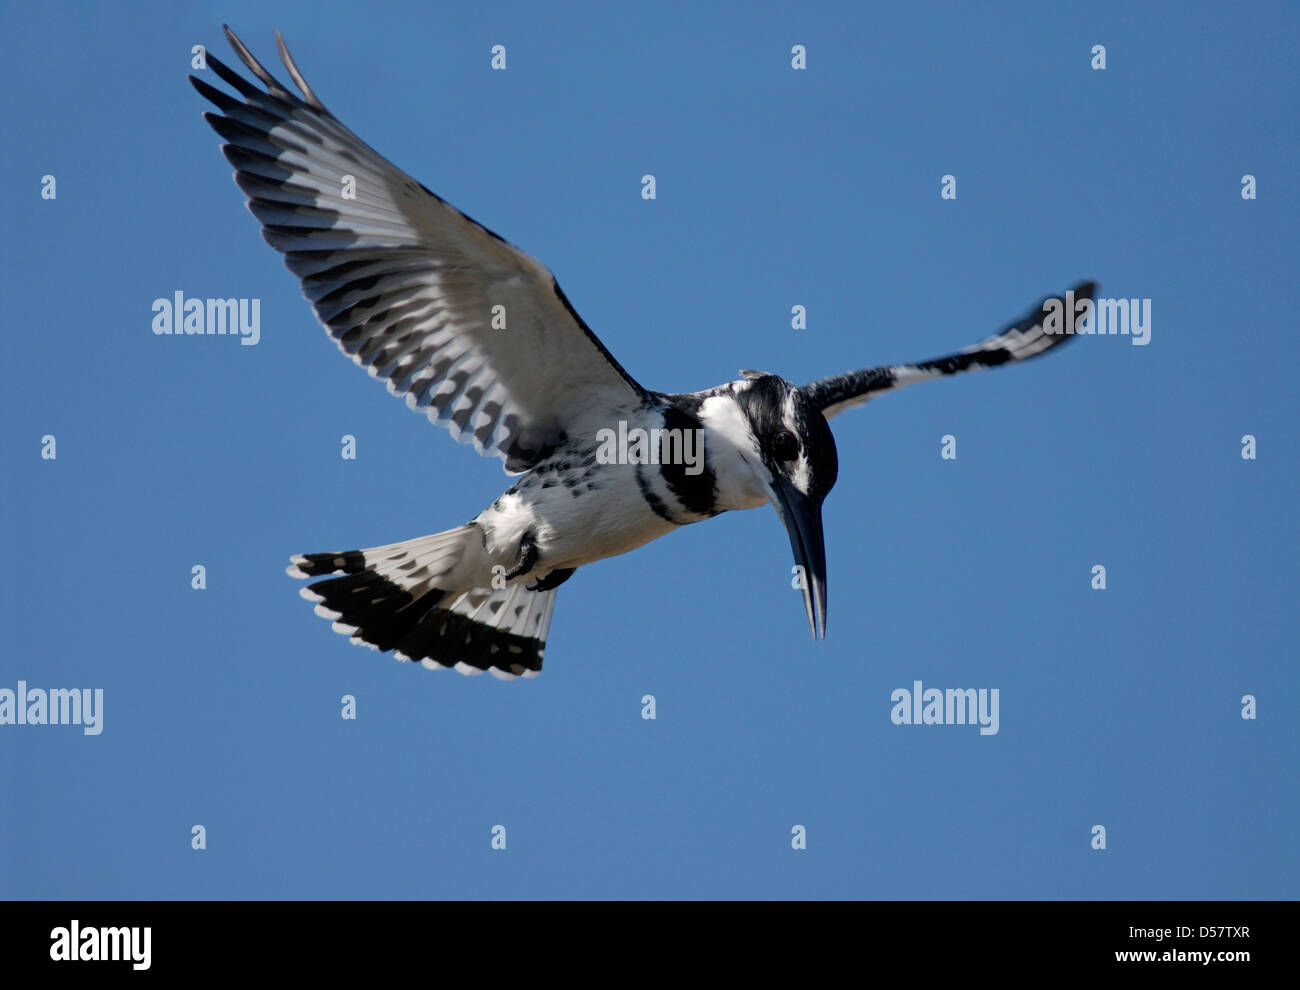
(801, 282, 1097, 420)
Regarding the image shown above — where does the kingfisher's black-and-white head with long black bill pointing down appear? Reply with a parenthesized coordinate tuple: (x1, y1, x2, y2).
(736, 372, 840, 639)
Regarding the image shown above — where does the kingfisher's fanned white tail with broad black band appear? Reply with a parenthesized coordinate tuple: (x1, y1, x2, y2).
(287, 524, 555, 679)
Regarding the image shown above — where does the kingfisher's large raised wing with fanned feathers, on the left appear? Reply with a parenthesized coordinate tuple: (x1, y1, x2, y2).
(190, 27, 646, 473)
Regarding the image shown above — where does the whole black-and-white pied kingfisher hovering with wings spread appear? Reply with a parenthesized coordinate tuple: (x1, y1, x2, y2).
(190, 27, 1096, 679)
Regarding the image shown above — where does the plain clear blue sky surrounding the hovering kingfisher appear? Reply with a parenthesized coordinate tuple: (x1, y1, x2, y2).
(0, 3, 1300, 899)
